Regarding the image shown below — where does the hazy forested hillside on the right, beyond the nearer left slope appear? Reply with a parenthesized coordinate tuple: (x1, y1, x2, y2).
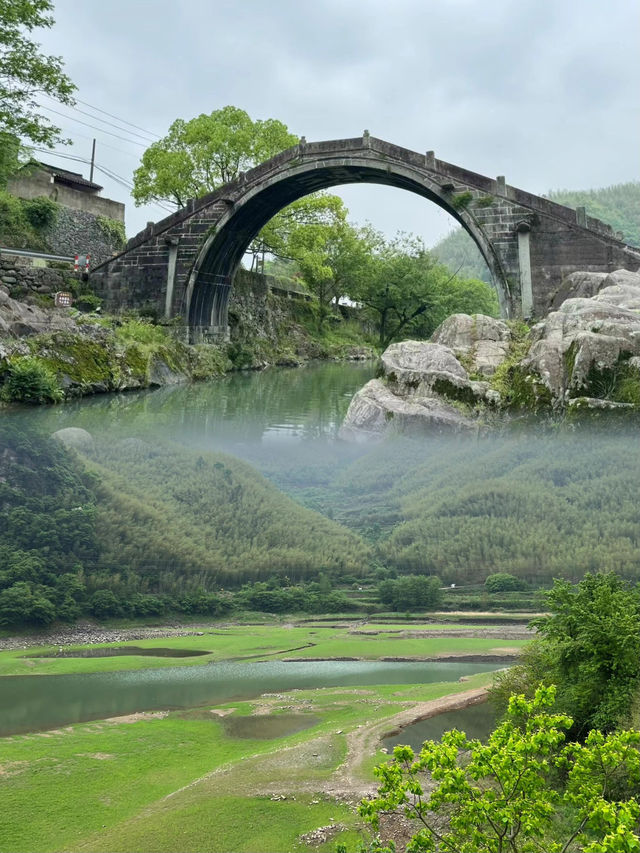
(298, 426, 640, 583)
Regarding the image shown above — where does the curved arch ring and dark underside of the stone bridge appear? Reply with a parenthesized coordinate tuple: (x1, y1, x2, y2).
(185, 137, 511, 329)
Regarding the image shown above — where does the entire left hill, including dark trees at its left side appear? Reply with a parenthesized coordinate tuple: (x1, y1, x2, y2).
(0, 424, 369, 627)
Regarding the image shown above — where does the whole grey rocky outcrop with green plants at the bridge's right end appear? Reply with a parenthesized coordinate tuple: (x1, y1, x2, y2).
(341, 270, 640, 439)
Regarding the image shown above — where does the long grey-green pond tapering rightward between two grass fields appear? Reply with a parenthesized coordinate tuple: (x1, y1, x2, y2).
(0, 660, 496, 736)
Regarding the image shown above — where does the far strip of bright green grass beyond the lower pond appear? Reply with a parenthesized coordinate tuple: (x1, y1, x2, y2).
(0, 624, 525, 676)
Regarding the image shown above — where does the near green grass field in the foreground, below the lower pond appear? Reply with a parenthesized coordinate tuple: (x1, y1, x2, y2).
(0, 674, 491, 853)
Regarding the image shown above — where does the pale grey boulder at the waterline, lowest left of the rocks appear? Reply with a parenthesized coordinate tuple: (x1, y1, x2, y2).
(340, 379, 474, 440)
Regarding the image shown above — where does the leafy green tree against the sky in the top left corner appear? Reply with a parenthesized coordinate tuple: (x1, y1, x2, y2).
(0, 0, 76, 149)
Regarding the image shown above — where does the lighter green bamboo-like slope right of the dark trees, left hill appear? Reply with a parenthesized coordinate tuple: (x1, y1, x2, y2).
(87, 439, 368, 591)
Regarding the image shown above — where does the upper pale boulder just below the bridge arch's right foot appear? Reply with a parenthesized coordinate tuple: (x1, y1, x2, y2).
(431, 314, 511, 376)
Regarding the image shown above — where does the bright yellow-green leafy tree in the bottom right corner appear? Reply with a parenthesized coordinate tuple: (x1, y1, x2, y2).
(360, 687, 640, 853)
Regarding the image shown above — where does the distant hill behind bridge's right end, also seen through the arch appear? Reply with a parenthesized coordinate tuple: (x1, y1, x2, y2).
(431, 182, 640, 282)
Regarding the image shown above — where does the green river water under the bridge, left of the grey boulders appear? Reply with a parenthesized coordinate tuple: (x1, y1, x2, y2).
(3, 362, 376, 456)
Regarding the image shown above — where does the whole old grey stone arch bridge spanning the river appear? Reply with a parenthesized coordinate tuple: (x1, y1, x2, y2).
(91, 131, 640, 339)
